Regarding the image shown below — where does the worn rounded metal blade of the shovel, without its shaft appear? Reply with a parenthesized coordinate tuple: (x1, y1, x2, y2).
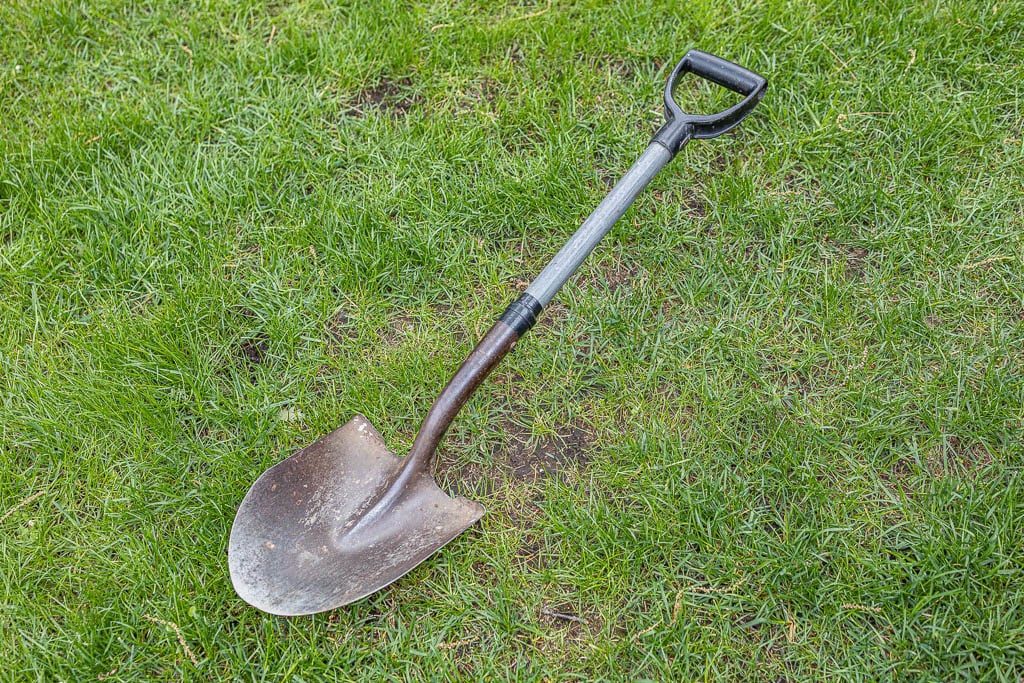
(227, 415, 483, 616)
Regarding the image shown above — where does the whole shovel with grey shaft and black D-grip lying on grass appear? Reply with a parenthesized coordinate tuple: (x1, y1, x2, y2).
(227, 50, 767, 616)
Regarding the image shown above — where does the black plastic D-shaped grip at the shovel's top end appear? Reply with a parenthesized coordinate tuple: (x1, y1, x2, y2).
(652, 50, 768, 155)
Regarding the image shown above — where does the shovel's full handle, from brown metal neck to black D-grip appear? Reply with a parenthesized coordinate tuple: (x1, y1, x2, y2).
(395, 50, 767, 483)
